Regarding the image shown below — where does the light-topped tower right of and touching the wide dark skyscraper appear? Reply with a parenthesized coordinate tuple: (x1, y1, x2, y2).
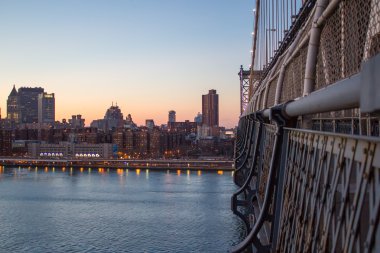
(38, 92, 55, 124)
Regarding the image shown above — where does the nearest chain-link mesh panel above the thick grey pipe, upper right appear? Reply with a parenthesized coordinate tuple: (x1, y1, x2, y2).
(315, 0, 372, 89)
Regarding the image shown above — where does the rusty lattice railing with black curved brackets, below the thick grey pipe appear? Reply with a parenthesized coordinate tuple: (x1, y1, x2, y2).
(231, 115, 380, 252)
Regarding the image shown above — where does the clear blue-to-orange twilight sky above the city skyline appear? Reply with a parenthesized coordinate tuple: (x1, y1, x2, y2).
(0, 0, 254, 127)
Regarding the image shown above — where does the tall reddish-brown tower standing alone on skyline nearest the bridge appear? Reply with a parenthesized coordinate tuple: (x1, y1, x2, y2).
(202, 90, 219, 127)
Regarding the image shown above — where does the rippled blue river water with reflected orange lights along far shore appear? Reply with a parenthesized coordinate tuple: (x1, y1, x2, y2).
(0, 167, 244, 252)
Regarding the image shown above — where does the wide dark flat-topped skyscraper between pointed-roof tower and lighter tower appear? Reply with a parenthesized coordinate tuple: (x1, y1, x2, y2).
(18, 87, 44, 123)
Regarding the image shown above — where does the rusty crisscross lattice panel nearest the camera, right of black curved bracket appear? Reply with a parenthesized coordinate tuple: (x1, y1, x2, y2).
(277, 129, 380, 252)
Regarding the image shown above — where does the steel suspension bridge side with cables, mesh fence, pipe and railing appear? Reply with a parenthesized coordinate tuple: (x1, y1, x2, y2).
(231, 0, 380, 252)
